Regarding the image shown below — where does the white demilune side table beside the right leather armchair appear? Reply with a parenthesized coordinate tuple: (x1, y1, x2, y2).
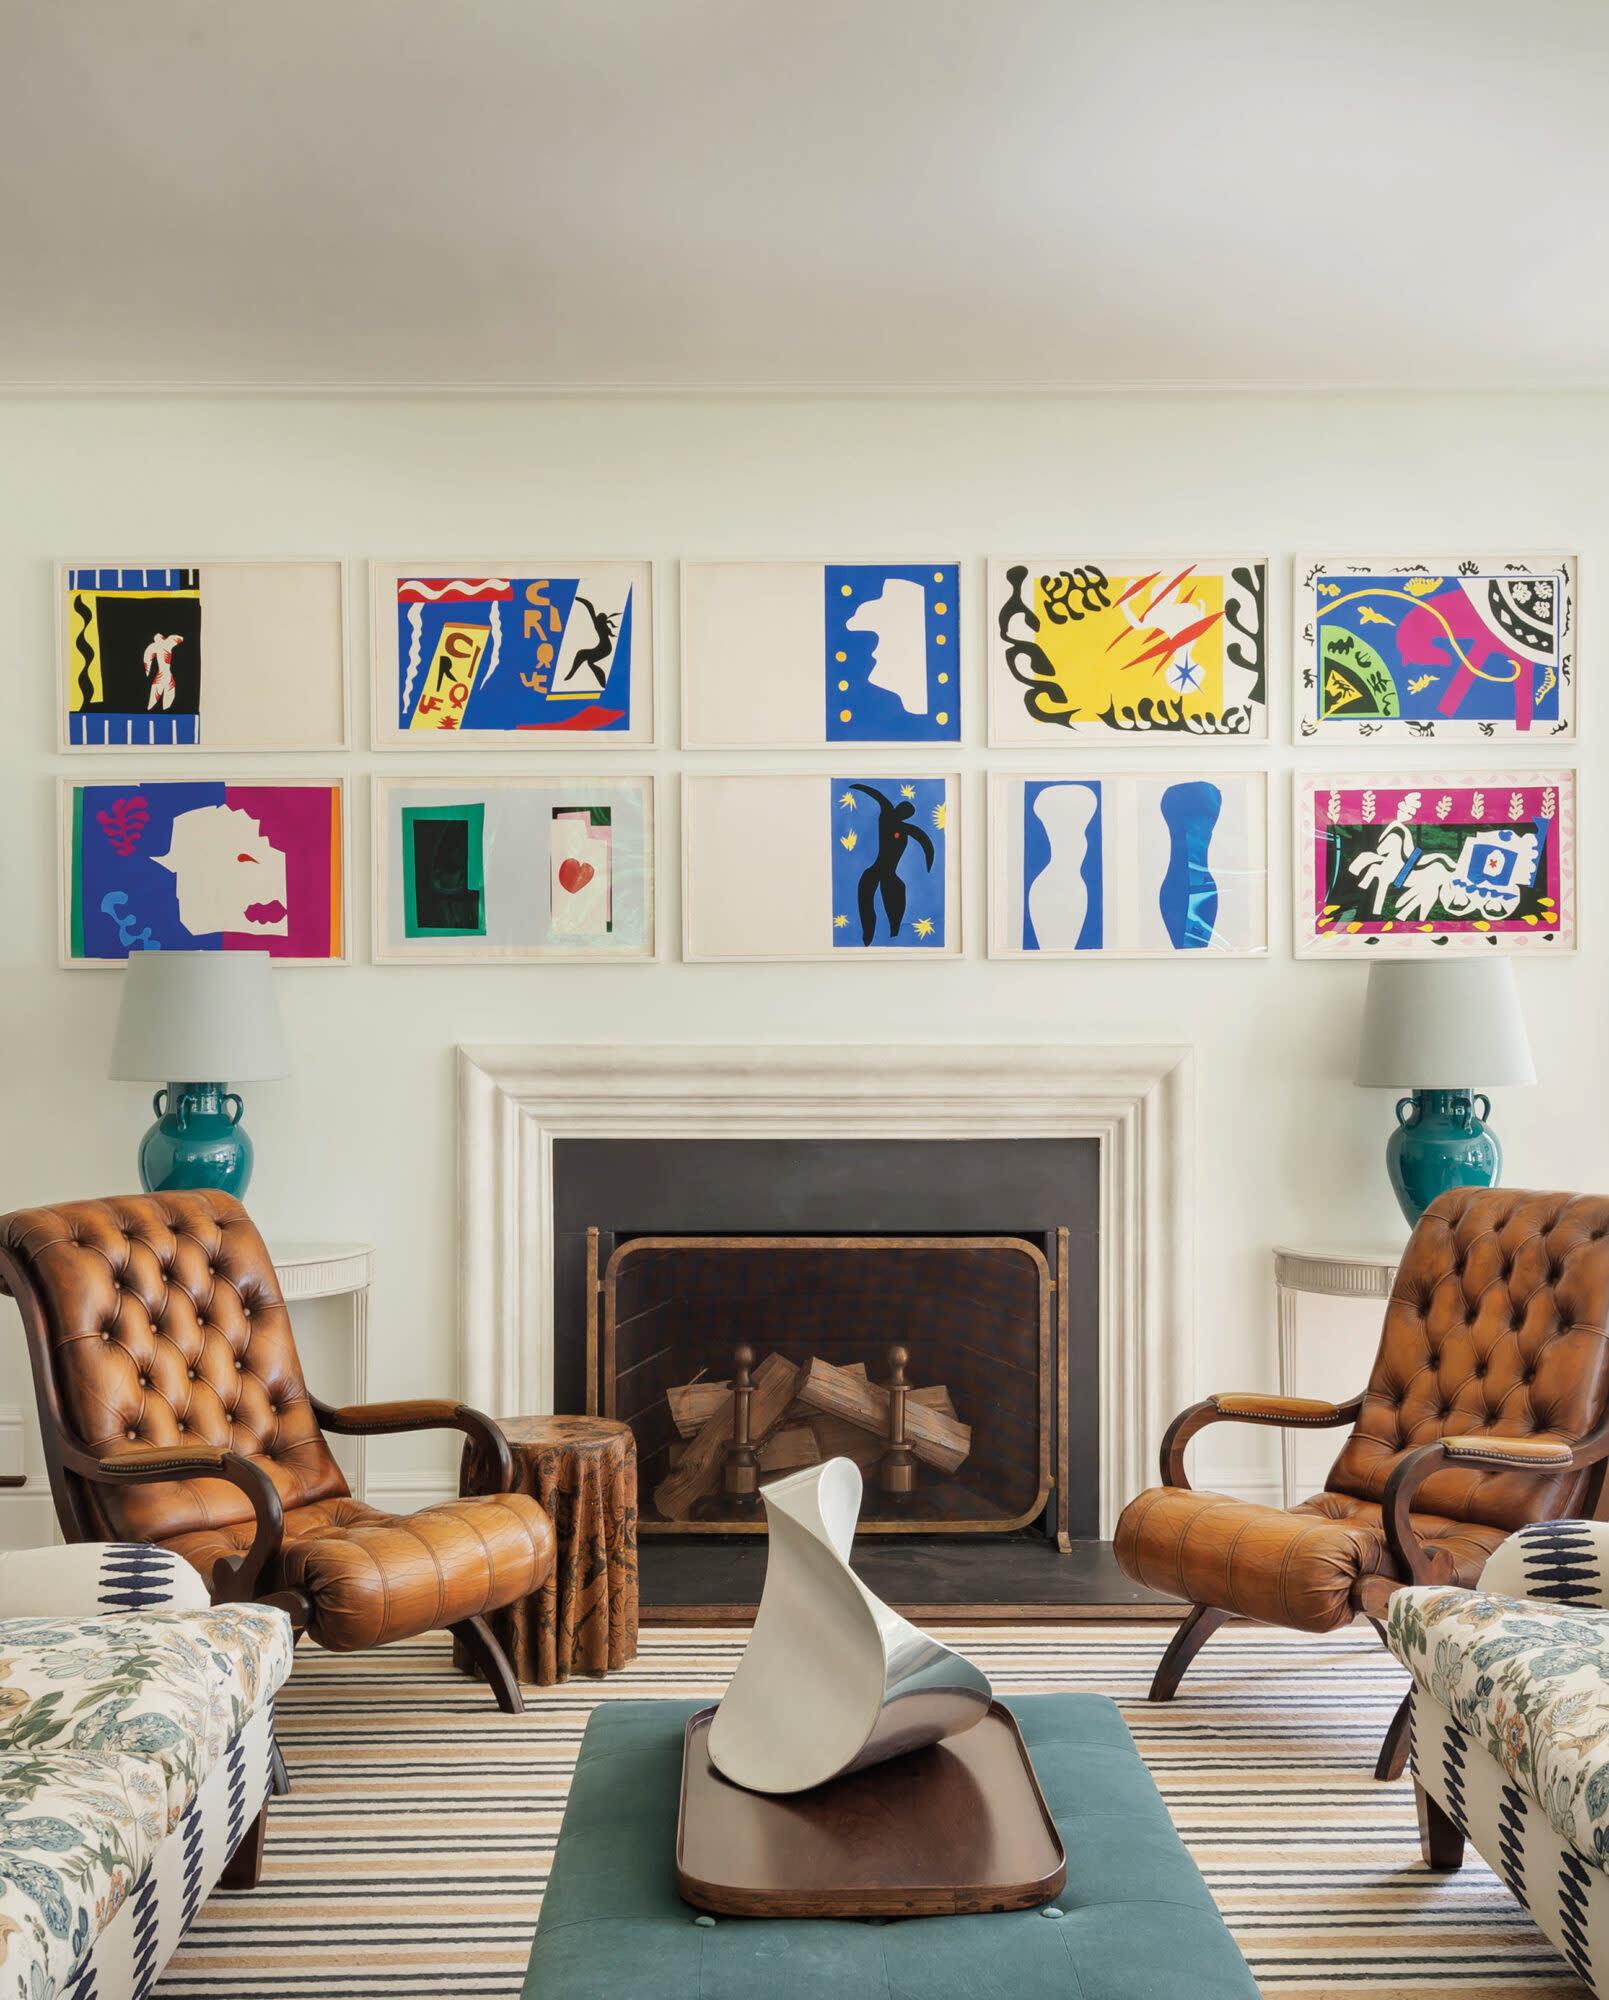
(1275, 1246, 1403, 1506)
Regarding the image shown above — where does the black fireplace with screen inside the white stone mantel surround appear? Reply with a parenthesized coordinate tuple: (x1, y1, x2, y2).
(550, 1136, 1096, 1584)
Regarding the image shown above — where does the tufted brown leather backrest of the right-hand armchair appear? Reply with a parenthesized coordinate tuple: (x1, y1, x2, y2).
(1325, 1188, 1609, 1528)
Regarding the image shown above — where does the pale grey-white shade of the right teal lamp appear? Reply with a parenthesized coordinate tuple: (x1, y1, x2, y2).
(1357, 952, 1537, 1090)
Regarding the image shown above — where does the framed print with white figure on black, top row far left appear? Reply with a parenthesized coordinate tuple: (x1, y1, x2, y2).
(56, 560, 346, 750)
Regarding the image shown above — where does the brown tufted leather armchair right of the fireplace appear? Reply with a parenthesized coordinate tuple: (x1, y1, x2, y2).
(1115, 1188, 1609, 1778)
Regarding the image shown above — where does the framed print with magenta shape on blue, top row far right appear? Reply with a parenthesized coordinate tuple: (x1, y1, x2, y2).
(1295, 556, 1575, 742)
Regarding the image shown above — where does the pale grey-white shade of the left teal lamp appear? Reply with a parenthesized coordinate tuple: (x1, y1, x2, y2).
(110, 952, 290, 1084)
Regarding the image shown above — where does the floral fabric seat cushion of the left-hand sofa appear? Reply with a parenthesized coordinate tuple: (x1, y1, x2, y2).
(0, 1604, 292, 2000)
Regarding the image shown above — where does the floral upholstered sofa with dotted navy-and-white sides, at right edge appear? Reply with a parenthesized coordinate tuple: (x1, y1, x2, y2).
(1387, 1520, 1609, 1994)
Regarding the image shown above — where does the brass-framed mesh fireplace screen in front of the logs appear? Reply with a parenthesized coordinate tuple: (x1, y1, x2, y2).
(588, 1236, 1061, 1534)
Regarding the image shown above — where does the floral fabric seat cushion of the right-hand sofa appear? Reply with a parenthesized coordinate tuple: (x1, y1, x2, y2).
(1387, 1586, 1609, 1870)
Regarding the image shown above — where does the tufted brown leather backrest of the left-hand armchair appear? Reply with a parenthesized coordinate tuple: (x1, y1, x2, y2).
(0, 1188, 346, 1542)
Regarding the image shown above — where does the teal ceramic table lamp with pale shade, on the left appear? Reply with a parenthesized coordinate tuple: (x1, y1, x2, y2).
(110, 952, 290, 1196)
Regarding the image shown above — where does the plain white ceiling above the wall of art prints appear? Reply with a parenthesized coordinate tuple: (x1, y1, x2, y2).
(0, 0, 1609, 388)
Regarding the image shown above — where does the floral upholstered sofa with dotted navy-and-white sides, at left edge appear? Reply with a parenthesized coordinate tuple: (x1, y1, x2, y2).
(0, 1542, 292, 2000)
